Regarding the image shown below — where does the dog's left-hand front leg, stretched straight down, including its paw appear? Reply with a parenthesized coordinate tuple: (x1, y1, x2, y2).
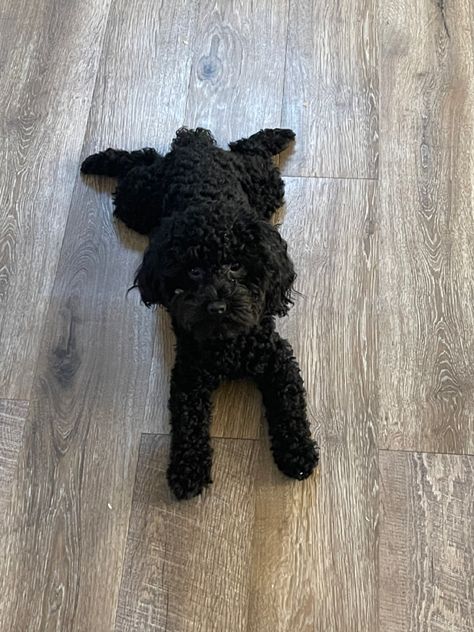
(167, 363, 212, 500)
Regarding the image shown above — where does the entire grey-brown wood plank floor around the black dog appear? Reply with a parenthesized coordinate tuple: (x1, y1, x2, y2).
(0, 0, 474, 632)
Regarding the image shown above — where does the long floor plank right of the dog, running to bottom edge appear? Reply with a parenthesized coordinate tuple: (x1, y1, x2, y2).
(249, 178, 379, 632)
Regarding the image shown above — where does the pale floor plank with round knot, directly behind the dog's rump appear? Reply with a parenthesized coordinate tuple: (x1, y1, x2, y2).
(186, 0, 289, 144)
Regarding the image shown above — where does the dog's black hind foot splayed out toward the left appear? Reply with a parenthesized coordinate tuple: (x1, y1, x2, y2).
(81, 147, 162, 178)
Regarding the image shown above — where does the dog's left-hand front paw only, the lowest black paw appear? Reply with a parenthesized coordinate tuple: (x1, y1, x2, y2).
(167, 454, 212, 500)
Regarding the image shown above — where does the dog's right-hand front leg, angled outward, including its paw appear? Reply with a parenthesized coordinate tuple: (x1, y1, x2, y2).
(257, 332, 319, 479)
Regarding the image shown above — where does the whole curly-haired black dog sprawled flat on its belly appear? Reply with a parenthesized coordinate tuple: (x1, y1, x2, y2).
(82, 128, 318, 498)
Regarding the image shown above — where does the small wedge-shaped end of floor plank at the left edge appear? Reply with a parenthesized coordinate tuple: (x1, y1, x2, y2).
(0, 399, 28, 512)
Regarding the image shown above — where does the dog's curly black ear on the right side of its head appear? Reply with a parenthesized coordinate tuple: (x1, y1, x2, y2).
(254, 221, 296, 316)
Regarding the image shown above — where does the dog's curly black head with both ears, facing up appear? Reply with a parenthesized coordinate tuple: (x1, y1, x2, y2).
(135, 208, 295, 341)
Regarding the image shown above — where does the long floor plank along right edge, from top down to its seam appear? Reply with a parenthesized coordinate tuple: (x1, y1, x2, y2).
(379, 0, 474, 453)
